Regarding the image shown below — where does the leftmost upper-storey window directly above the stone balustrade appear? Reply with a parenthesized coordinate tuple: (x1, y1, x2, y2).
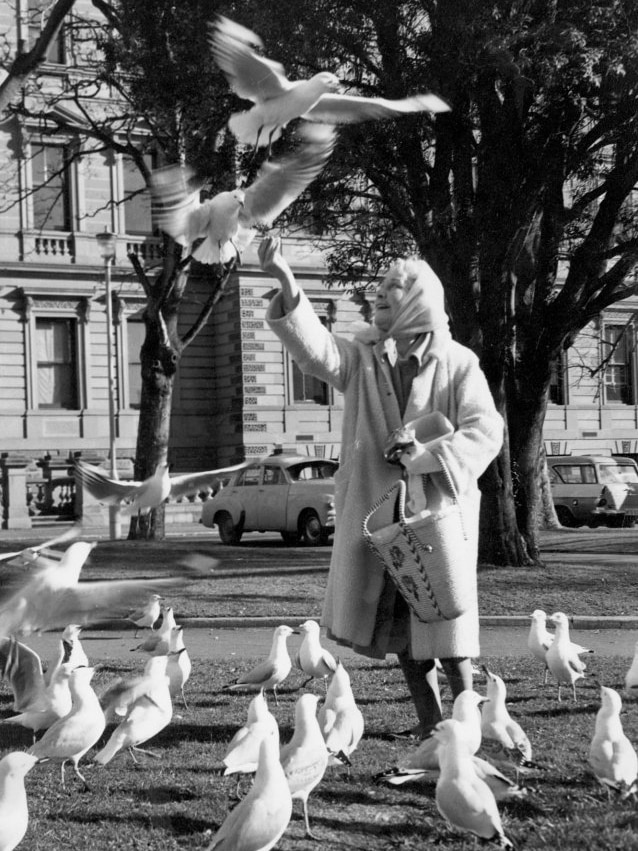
(31, 145, 71, 231)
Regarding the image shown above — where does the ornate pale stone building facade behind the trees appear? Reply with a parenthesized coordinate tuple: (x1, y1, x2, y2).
(0, 0, 638, 528)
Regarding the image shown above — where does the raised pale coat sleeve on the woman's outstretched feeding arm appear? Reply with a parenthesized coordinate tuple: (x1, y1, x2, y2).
(266, 292, 356, 392)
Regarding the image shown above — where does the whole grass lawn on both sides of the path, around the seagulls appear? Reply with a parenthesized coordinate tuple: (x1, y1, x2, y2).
(0, 540, 638, 851)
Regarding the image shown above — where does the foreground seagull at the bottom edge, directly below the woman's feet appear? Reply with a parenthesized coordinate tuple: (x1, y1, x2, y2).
(432, 719, 514, 848)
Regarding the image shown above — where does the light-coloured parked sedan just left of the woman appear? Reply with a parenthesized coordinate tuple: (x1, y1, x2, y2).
(202, 454, 339, 546)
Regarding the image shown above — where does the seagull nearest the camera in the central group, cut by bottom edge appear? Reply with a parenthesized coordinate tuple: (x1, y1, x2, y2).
(206, 730, 292, 851)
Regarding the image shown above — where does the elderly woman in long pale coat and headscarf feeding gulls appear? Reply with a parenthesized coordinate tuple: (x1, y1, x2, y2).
(259, 238, 503, 736)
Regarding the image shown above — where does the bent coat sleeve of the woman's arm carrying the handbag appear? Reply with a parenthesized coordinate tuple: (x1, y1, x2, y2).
(435, 351, 503, 493)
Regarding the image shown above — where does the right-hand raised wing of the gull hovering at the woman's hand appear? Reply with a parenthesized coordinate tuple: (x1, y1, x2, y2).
(239, 125, 336, 227)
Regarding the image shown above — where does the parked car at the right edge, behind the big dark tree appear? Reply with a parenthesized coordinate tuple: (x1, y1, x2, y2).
(547, 455, 638, 526)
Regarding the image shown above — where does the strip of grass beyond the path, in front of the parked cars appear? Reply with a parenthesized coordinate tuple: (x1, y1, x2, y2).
(7, 539, 638, 618)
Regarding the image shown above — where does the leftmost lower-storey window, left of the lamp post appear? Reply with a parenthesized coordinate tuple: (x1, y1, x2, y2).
(35, 318, 78, 410)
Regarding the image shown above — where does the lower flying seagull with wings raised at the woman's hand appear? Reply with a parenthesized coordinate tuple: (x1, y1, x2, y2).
(150, 120, 336, 264)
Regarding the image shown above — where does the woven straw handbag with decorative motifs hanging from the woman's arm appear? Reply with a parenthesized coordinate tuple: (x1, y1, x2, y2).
(363, 459, 473, 623)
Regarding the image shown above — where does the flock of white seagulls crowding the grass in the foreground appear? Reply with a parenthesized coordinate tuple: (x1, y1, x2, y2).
(0, 529, 638, 851)
